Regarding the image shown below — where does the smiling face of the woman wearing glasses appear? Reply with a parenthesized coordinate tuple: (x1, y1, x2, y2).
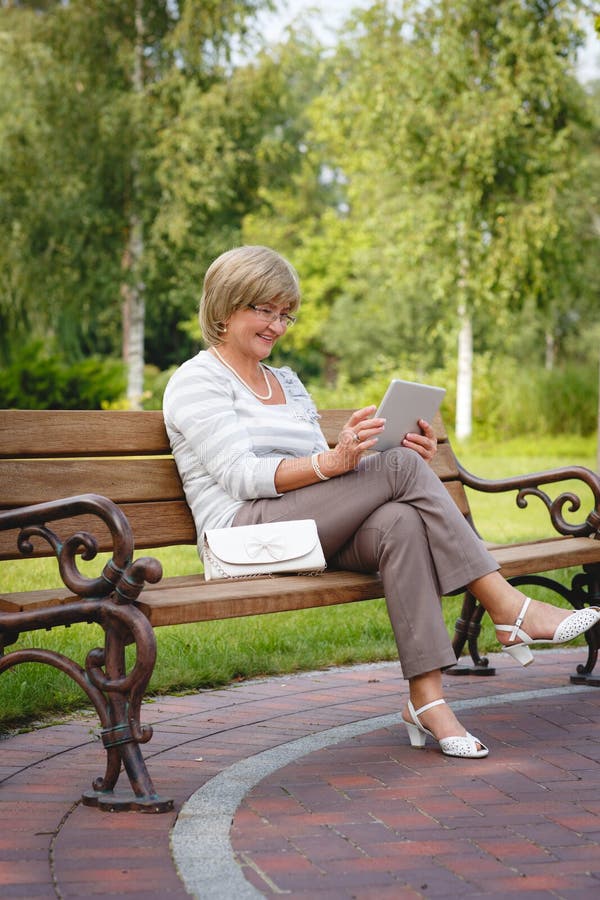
(223, 300, 291, 360)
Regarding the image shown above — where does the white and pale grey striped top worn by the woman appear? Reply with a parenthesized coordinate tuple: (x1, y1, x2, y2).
(163, 350, 327, 554)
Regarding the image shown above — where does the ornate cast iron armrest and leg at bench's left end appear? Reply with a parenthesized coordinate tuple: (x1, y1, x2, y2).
(0, 494, 173, 812)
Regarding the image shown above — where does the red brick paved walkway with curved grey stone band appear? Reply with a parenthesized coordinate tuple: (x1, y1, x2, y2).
(0, 648, 600, 900)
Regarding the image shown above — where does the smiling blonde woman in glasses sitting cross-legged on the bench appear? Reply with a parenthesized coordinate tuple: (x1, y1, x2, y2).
(164, 246, 600, 757)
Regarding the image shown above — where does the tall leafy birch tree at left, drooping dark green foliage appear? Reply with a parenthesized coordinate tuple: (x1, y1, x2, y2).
(0, 0, 269, 405)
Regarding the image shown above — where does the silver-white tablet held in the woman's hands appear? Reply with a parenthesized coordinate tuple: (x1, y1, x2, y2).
(373, 378, 446, 450)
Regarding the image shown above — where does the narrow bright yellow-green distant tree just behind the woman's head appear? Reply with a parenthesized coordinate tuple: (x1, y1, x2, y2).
(242, 28, 352, 377)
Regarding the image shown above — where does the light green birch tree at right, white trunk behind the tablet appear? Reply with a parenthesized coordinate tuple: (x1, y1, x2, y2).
(247, 0, 597, 436)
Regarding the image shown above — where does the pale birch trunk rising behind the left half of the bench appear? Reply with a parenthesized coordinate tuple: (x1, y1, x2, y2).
(121, 0, 146, 409)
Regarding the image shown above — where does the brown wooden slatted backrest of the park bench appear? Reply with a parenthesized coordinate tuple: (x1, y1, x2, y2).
(0, 410, 469, 559)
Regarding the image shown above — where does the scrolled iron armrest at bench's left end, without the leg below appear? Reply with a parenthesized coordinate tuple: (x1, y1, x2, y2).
(0, 494, 162, 603)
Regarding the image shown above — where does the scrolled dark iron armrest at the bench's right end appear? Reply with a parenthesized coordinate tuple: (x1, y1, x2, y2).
(457, 462, 600, 539)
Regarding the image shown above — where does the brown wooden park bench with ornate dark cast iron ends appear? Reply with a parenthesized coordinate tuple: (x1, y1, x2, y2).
(0, 410, 600, 812)
